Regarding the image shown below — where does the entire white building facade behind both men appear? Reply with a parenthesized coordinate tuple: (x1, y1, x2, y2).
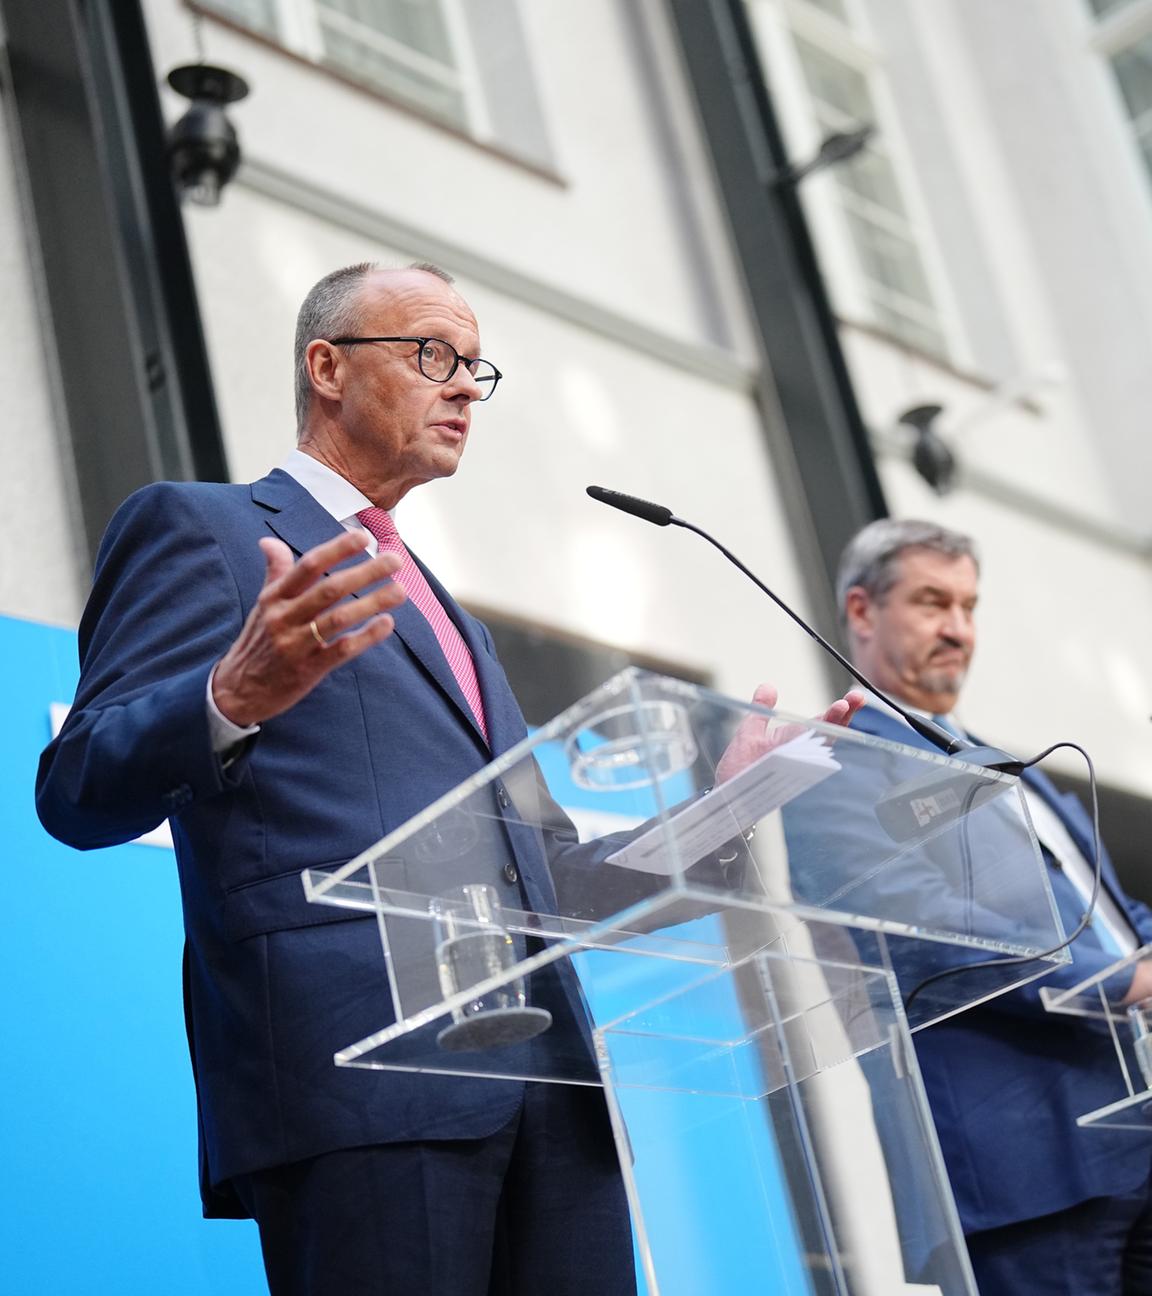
(0, 0, 1152, 792)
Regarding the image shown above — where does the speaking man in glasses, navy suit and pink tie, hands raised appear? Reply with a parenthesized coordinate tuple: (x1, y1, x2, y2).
(38, 257, 859, 1296)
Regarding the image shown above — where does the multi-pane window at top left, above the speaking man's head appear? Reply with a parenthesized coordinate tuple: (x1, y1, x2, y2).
(198, 0, 552, 166)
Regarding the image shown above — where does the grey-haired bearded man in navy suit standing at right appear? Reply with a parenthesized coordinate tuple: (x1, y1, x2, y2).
(837, 521, 1152, 1296)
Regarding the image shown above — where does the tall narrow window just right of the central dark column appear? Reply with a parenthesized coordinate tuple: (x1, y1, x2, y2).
(792, 16, 947, 355)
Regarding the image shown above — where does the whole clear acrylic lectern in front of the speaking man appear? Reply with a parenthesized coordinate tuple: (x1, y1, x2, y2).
(305, 670, 1064, 1296)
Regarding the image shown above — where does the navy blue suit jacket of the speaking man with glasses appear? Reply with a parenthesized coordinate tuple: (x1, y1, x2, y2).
(38, 470, 583, 1214)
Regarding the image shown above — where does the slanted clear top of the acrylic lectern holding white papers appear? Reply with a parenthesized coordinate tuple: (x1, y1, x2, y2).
(305, 670, 1068, 1045)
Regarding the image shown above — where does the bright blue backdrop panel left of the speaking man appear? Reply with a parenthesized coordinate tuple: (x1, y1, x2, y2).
(0, 617, 264, 1296)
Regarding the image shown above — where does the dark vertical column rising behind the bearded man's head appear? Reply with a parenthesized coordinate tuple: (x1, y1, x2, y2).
(667, 0, 888, 593)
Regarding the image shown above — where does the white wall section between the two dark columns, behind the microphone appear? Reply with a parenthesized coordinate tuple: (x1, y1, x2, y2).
(157, 0, 827, 712)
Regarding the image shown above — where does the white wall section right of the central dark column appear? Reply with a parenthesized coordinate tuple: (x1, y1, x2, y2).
(750, 0, 1152, 794)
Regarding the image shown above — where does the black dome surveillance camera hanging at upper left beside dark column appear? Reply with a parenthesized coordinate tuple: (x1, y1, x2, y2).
(167, 64, 248, 207)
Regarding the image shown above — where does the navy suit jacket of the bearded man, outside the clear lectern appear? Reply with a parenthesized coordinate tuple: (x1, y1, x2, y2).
(828, 706, 1152, 1232)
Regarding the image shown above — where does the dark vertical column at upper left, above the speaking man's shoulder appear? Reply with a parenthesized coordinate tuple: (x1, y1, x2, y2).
(0, 0, 228, 567)
